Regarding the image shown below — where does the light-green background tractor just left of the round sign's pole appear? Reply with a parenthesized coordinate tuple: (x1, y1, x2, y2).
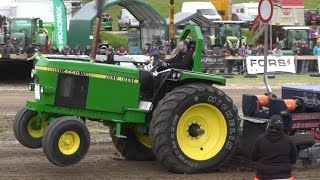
(211, 21, 247, 54)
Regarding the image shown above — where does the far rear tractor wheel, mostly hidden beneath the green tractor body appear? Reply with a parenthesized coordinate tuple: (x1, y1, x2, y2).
(109, 127, 156, 161)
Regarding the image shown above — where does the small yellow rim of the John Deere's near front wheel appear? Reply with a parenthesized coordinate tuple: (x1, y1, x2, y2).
(58, 131, 80, 155)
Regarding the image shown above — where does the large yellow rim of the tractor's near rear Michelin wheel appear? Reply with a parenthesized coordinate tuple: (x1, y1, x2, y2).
(177, 103, 227, 161)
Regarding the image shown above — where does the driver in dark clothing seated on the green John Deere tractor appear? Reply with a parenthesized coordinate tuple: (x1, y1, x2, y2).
(162, 40, 193, 71)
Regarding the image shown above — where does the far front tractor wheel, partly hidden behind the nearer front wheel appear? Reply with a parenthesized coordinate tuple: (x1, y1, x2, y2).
(13, 108, 48, 149)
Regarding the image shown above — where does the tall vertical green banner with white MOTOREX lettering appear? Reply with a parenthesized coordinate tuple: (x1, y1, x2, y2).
(53, 0, 67, 48)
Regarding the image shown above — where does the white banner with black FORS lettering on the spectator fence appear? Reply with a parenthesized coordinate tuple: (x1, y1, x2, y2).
(246, 56, 296, 74)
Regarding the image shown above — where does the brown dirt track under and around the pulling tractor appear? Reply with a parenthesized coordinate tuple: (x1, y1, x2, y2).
(0, 83, 320, 180)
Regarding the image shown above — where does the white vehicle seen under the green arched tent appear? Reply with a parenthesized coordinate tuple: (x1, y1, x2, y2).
(118, 9, 140, 31)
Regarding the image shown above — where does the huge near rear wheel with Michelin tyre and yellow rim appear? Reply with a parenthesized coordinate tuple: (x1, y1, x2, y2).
(150, 84, 239, 173)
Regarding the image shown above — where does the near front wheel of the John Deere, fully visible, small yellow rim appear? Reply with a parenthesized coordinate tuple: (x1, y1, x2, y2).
(42, 117, 90, 166)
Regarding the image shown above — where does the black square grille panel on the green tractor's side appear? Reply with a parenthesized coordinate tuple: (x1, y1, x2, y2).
(55, 74, 89, 108)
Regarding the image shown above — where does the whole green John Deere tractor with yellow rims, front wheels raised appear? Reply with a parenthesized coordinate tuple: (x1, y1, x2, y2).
(13, 19, 240, 173)
